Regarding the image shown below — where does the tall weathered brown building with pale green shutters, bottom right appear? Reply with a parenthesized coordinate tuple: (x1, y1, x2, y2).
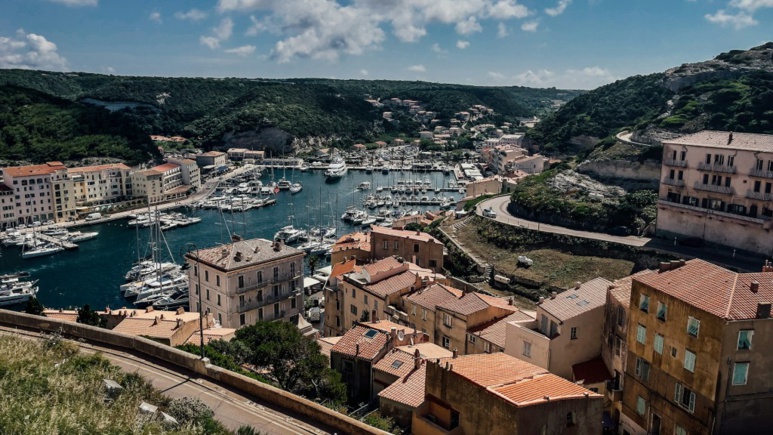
(620, 259, 773, 434)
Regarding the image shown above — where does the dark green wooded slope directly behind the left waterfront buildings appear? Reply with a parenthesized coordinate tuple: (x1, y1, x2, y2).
(0, 86, 157, 163)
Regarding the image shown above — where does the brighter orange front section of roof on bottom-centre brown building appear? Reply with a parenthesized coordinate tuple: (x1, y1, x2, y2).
(491, 373, 603, 406)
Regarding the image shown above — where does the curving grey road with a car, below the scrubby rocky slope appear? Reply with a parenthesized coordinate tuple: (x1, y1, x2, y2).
(475, 195, 765, 272)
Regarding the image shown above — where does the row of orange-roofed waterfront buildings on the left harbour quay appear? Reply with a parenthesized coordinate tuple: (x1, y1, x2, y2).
(0, 158, 201, 229)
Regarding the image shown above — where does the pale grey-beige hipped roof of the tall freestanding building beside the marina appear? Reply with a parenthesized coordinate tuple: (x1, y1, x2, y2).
(185, 239, 303, 271)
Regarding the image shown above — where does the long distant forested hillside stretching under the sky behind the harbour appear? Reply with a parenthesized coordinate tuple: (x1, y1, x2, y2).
(0, 70, 581, 162)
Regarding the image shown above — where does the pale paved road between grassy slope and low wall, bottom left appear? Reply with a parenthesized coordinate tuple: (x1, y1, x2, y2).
(0, 327, 331, 435)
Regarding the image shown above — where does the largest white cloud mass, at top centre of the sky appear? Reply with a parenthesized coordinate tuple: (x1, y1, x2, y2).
(217, 0, 533, 62)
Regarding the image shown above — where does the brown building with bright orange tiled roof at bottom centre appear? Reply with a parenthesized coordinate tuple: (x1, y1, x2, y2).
(411, 353, 603, 435)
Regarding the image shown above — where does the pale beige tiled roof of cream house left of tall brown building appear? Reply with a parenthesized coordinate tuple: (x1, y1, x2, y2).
(539, 278, 612, 321)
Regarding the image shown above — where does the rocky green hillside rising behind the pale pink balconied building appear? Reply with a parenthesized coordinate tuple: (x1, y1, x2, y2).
(529, 43, 773, 155)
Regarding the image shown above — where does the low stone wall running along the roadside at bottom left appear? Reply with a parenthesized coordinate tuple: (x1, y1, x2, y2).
(0, 309, 385, 434)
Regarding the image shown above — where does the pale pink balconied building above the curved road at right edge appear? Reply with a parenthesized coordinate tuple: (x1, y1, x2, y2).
(657, 131, 773, 255)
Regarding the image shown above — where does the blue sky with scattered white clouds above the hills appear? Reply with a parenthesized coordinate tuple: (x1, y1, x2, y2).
(0, 0, 773, 89)
